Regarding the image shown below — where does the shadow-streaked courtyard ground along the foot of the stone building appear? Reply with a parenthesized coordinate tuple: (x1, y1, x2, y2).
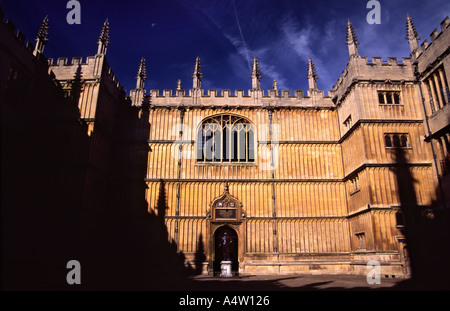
(76, 271, 450, 292)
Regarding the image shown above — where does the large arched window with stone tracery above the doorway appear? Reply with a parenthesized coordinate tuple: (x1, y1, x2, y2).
(197, 114, 255, 163)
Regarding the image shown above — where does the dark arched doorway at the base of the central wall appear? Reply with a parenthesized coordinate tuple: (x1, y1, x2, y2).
(214, 226, 239, 275)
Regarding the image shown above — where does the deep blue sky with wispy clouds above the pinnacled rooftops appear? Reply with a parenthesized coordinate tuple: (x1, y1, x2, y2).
(0, 0, 450, 91)
